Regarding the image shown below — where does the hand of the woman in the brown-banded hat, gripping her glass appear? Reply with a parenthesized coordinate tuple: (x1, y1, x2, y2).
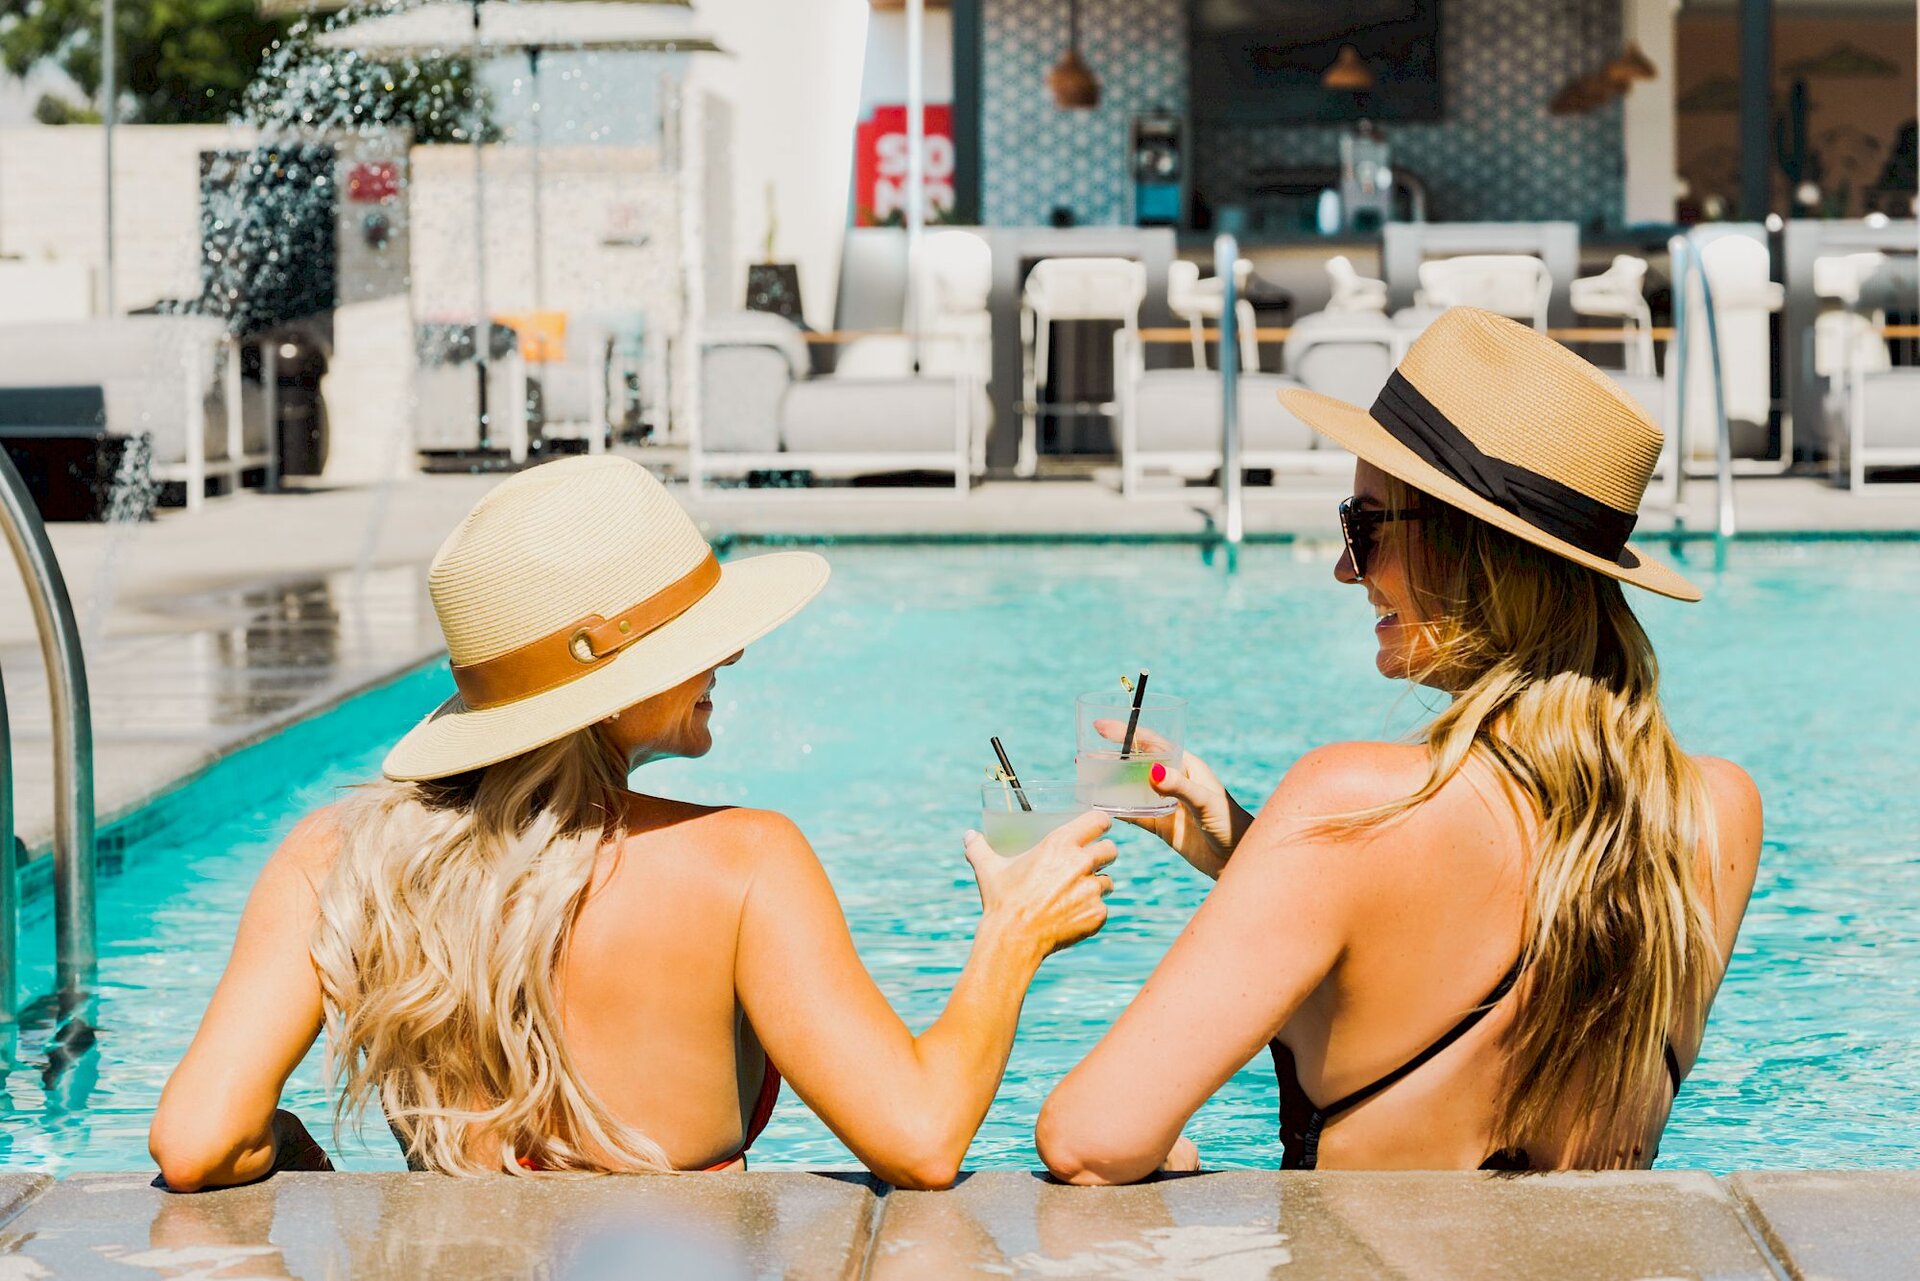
(966, 810, 1117, 958)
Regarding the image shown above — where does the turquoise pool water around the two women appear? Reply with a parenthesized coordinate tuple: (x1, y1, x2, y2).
(0, 542, 1920, 1173)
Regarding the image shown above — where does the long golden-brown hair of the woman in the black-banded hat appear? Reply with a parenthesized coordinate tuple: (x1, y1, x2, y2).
(1354, 476, 1718, 1168)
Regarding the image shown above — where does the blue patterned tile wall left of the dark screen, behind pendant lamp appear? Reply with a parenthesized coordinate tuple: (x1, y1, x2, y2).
(979, 0, 1187, 227)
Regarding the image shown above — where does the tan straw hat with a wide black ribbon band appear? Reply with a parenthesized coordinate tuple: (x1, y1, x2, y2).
(1281, 307, 1699, 601)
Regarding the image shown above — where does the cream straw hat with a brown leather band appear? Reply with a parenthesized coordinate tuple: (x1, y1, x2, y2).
(382, 455, 828, 780)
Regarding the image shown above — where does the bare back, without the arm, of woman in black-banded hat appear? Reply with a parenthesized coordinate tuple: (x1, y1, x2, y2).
(1279, 743, 1759, 1170)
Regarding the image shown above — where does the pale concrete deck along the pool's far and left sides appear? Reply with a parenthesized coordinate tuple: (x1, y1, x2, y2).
(0, 474, 1920, 855)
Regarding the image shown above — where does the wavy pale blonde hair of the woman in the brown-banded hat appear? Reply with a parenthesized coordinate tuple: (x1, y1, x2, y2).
(313, 730, 670, 1173)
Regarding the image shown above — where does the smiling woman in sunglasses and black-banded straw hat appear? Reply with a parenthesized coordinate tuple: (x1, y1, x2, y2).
(1037, 307, 1761, 1183)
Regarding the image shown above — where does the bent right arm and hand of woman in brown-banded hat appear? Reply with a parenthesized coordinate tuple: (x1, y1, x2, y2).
(735, 812, 1114, 1187)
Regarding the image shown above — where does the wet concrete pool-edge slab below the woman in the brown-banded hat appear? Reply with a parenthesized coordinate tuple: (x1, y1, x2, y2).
(0, 1173, 876, 1281)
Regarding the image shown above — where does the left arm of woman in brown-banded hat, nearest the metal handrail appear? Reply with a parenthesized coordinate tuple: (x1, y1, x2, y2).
(148, 814, 332, 1193)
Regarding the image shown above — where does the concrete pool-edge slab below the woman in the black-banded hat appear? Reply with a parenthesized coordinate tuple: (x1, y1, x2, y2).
(872, 1172, 1772, 1281)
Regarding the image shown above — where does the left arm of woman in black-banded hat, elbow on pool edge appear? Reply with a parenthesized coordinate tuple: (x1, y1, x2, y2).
(1035, 743, 1382, 1183)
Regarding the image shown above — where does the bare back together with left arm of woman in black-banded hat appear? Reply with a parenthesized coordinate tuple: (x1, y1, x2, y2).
(1037, 743, 1761, 1181)
